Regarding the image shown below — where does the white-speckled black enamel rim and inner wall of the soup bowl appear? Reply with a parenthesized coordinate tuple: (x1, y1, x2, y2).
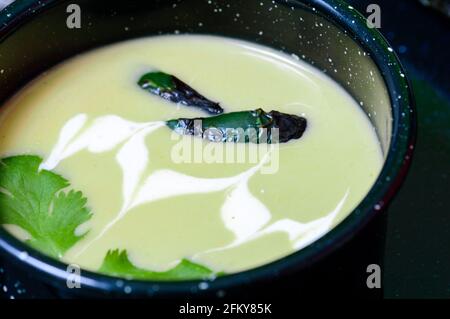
(0, 0, 416, 297)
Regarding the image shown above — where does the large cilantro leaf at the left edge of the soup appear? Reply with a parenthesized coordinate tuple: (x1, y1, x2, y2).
(0, 155, 92, 257)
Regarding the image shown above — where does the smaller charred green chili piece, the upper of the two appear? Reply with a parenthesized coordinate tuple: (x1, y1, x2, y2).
(138, 71, 223, 115)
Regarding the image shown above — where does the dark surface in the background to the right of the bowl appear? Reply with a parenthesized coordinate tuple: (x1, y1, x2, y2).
(0, 0, 450, 298)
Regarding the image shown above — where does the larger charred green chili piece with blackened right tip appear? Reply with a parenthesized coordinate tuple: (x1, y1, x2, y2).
(166, 109, 307, 144)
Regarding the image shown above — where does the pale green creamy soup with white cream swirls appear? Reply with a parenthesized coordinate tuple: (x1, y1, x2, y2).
(0, 35, 383, 279)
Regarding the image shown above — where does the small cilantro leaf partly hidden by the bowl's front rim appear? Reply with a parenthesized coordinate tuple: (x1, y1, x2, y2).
(99, 249, 218, 280)
